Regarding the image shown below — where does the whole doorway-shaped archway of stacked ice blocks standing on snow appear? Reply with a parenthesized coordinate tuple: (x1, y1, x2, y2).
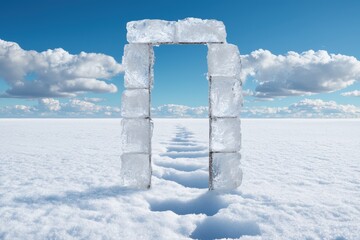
(121, 18, 242, 190)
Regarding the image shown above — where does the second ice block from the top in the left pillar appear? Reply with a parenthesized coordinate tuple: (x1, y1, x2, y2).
(121, 89, 150, 118)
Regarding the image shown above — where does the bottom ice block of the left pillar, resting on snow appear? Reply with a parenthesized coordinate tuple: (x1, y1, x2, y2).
(120, 153, 151, 189)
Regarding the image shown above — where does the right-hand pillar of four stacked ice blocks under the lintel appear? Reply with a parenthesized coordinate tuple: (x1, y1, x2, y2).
(208, 43, 242, 190)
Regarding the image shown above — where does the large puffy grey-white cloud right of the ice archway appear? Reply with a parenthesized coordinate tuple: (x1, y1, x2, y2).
(242, 49, 360, 98)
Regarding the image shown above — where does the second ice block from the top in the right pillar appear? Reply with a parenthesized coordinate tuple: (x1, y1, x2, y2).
(210, 77, 243, 117)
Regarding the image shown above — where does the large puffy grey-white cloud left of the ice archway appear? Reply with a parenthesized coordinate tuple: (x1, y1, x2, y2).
(0, 39, 123, 98)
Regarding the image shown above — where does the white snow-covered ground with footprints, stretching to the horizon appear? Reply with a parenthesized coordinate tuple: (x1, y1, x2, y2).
(0, 119, 360, 240)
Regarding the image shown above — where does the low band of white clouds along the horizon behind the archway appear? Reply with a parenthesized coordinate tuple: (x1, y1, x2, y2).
(0, 98, 360, 118)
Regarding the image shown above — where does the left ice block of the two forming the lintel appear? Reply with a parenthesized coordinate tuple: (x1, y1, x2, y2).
(126, 19, 175, 44)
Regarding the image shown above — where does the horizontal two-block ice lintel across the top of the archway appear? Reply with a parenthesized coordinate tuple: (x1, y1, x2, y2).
(126, 18, 226, 45)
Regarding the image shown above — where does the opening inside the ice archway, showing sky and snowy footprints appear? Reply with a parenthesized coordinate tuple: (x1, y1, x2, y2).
(151, 45, 209, 189)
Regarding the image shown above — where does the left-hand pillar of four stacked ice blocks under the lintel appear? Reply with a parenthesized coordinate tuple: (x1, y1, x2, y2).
(121, 43, 154, 189)
